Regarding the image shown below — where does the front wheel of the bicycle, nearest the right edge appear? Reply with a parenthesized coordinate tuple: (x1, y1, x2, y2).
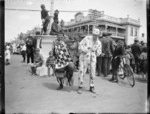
(125, 65, 135, 87)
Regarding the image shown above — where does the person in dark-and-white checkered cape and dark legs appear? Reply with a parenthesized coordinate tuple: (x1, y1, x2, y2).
(52, 33, 74, 90)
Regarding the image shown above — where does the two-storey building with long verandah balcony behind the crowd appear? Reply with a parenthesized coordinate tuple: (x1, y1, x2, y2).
(64, 12, 140, 44)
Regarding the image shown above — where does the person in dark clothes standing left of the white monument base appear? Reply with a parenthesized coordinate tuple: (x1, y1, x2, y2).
(26, 36, 35, 63)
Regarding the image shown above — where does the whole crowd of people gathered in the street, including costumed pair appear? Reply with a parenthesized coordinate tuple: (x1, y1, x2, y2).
(5, 4, 147, 94)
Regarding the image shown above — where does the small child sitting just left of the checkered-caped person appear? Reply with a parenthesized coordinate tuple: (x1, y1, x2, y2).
(46, 51, 55, 76)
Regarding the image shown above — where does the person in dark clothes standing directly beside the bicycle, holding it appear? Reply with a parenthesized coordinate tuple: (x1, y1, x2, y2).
(110, 40, 125, 82)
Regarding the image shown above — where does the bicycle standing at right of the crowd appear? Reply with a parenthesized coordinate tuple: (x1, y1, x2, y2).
(118, 57, 135, 87)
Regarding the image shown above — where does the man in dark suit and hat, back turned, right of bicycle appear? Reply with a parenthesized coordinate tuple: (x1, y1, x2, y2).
(131, 38, 142, 74)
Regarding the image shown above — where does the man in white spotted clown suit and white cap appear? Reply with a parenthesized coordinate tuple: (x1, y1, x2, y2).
(77, 28, 102, 94)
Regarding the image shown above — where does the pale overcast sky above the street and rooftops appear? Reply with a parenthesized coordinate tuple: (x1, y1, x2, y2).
(5, 0, 147, 42)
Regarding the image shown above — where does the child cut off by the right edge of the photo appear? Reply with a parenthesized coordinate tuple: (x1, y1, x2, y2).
(139, 47, 147, 80)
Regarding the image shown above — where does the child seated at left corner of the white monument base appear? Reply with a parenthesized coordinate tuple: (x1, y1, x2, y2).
(31, 48, 44, 75)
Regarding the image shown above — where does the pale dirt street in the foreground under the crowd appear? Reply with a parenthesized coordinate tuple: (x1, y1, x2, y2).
(5, 55, 147, 114)
